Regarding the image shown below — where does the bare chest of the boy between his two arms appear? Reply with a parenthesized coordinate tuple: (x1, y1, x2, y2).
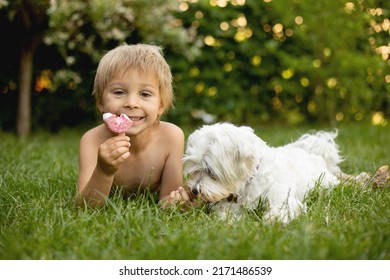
(114, 150, 166, 191)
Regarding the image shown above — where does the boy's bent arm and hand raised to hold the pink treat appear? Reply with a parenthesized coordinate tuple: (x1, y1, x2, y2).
(76, 131, 130, 207)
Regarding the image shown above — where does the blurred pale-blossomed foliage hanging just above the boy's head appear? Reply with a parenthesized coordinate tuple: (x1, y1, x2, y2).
(45, 0, 200, 67)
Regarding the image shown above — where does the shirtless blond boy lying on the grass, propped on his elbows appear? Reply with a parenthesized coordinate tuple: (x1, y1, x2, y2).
(77, 44, 188, 207)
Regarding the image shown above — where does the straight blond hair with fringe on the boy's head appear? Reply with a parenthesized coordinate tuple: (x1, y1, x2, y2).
(92, 44, 174, 111)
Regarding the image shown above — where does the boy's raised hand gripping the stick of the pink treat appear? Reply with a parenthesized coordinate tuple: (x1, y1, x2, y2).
(97, 135, 131, 175)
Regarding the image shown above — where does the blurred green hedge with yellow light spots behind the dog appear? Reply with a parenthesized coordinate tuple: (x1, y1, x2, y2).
(173, 0, 390, 123)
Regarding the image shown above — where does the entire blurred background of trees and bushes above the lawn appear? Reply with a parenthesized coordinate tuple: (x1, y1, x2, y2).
(0, 0, 390, 137)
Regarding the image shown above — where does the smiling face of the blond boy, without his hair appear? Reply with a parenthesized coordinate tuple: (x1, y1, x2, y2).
(98, 68, 164, 134)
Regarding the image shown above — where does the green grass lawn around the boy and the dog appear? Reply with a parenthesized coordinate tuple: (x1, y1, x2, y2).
(0, 124, 390, 260)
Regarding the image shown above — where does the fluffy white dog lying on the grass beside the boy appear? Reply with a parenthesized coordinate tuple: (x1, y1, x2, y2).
(183, 123, 342, 223)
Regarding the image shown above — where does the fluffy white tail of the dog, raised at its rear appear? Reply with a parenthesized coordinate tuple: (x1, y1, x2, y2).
(288, 130, 343, 176)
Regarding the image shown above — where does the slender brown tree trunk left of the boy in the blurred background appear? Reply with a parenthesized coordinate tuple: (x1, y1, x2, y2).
(16, 44, 34, 138)
